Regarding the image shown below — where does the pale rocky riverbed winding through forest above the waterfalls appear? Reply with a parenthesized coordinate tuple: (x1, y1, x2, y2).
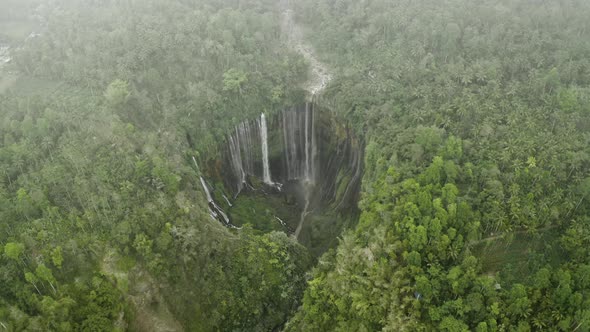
(282, 8, 332, 97)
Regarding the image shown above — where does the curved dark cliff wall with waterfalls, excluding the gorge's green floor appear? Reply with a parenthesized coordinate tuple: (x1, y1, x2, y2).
(201, 102, 364, 255)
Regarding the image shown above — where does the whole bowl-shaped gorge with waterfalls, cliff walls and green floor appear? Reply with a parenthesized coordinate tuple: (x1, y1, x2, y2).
(195, 102, 363, 254)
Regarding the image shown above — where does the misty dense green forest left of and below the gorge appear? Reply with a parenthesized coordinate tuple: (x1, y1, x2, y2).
(0, 1, 309, 331)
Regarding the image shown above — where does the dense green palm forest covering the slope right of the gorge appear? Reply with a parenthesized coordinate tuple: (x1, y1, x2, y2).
(289, 0, 590, 331)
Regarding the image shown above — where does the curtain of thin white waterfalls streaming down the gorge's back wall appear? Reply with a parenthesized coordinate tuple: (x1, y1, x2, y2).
(226, 103, 319, 198)
